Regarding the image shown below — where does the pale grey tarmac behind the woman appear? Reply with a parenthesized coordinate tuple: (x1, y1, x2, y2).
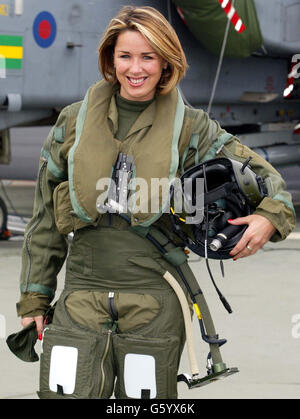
(0, 181, 300, 400)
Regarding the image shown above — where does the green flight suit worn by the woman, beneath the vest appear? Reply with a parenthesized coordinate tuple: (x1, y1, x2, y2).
(17, 82, 295, 398)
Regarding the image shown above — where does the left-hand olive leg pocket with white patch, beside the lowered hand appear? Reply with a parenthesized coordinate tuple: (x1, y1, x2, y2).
(38, 325, 114, 399)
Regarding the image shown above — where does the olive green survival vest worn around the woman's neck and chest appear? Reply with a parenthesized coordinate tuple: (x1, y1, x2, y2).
(68, 80, 185, 227)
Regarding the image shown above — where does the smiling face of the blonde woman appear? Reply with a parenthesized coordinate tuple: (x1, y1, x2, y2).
(114, 30, 166, 101)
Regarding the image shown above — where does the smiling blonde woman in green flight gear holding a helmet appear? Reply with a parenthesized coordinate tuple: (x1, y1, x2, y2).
(17, 7, 294, 398)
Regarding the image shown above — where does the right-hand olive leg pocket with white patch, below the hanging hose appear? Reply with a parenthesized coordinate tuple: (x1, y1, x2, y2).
(113, 334, 180, 399)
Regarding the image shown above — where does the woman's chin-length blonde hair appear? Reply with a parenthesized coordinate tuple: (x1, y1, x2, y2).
(98, 6, 187, 94)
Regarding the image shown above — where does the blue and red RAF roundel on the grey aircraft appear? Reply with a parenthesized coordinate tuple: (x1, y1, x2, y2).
(33, 12, 56, 48)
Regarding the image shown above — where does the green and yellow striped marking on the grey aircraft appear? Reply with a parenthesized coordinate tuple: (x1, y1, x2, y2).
(0, 35, 23, 70)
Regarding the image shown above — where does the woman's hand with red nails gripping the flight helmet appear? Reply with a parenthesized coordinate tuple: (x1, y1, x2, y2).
(228, 214, 276, 260)
